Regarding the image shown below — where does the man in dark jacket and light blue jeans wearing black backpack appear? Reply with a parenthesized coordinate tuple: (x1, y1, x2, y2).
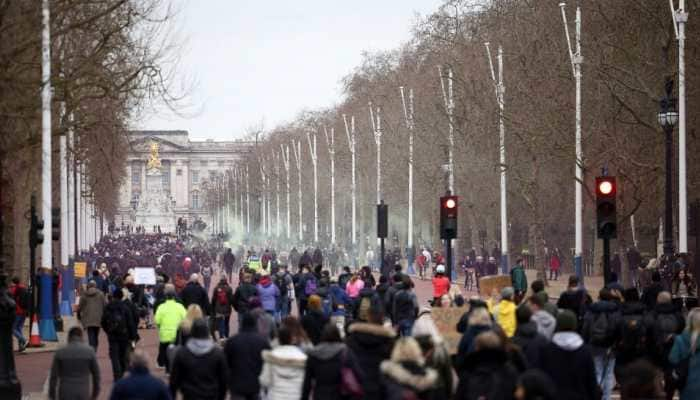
(582, 288, 622, 400)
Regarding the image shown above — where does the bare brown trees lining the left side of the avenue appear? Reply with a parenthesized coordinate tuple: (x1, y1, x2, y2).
(0, 0, 186, 282)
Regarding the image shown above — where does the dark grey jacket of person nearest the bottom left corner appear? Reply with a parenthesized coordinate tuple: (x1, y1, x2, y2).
(47, 340, 100, 400)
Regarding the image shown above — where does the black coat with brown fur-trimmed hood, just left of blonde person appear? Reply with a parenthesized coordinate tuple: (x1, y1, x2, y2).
(345, 322, 396, 400)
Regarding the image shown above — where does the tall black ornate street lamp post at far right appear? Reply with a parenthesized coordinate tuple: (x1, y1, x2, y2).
(657, 78, 678, 260)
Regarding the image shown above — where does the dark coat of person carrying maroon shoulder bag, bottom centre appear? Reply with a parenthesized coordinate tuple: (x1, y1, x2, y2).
(301, 342, 364, 400)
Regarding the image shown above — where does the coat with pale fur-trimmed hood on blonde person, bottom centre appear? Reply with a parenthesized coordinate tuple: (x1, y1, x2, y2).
(379, 360, 438, 400)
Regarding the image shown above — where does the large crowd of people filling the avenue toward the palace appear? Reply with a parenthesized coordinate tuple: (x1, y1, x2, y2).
(11, 234, 700, 400)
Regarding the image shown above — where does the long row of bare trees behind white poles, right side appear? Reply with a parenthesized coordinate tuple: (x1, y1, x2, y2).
(226, 0, 700, 284)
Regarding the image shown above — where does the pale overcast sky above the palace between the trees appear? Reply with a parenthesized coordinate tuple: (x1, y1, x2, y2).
(135, 0, 442, 140)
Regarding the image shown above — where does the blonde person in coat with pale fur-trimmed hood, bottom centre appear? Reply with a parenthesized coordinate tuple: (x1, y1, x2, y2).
(379, 336, 438, 400)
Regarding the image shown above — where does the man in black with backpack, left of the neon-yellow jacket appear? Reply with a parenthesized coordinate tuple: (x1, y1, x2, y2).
(102, 289, 139, 382)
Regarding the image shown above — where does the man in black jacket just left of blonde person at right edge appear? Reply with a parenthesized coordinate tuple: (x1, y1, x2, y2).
(644, 291, 685, 399)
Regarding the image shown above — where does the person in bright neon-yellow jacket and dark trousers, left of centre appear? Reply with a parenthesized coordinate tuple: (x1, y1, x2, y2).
(154, 283, 187, 371)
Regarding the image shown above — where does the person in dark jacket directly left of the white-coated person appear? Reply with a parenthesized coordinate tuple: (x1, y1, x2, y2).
(224, 313, 270, 400)
